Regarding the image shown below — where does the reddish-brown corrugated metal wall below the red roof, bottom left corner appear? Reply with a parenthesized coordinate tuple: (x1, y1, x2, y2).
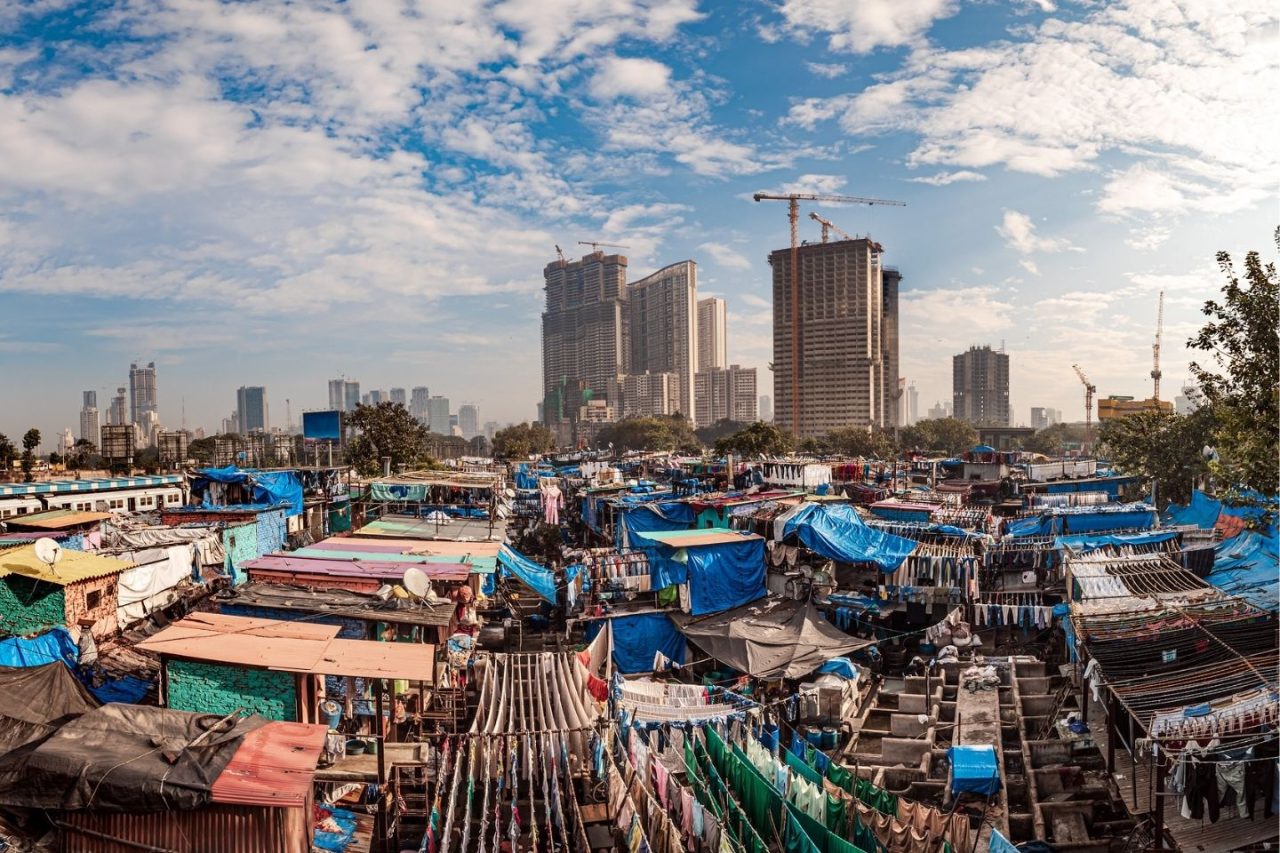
(61, 806, 311, 853)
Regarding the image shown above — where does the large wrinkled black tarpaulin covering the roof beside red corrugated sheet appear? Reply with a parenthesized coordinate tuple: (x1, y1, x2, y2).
(0, 704, 266, 812)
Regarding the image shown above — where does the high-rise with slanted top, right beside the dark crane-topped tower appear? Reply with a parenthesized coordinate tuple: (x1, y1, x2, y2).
(626, 260, 698, 420)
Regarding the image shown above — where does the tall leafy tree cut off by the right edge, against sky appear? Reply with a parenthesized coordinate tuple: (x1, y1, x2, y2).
(1187, 228, 1280, 494)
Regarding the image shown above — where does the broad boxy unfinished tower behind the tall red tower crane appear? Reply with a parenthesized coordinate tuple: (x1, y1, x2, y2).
(769, 238, 896, 438)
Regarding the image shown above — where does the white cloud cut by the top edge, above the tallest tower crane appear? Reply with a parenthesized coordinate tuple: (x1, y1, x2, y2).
(782, 0, 960, 54)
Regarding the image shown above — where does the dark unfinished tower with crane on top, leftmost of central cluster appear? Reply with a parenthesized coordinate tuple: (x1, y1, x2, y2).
(543, 251, 628, 424)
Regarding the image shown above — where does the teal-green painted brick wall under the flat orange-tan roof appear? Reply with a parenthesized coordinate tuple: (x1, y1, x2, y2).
(165, 660, 297, 721)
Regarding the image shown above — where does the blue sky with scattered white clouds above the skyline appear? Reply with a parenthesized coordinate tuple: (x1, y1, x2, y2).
(0, 0, 1280, 446)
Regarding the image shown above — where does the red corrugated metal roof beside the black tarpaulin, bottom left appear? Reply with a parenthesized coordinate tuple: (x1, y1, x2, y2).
(212, 722, 328, 807)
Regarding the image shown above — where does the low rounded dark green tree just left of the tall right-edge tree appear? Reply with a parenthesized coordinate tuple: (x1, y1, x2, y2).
(1098, 409, 1213, 505)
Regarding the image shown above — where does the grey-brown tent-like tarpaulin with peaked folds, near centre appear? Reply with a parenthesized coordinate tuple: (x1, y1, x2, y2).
(672, 598, 872, 679)
